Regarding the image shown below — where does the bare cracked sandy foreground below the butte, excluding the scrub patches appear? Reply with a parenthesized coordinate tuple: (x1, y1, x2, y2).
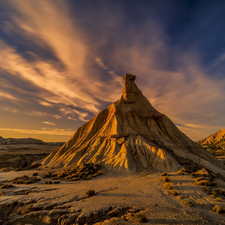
(0, 170, 225, 225)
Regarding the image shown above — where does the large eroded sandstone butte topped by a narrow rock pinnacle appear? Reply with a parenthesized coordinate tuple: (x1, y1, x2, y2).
(42, 74, 225, 177)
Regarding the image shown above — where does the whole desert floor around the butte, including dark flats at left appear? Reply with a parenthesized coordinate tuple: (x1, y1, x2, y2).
(0, 142, 225, 225)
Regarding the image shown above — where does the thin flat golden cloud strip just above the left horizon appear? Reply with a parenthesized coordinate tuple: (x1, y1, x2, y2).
(0, 128, 73, 135)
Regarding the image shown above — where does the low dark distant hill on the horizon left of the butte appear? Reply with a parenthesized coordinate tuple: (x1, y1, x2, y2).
(0, 136, 46, 145)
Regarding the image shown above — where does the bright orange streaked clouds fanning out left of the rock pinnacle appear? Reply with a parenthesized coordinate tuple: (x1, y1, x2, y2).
(0, 0, 123, 120)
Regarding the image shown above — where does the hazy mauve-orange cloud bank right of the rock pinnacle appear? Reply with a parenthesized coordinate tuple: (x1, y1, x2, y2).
(106, 21, 225, 140)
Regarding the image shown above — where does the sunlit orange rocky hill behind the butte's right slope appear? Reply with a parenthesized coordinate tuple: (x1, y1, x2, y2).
(198, 129, 225, 148)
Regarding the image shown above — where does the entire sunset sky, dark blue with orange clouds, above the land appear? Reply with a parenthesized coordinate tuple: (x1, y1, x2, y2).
(0, 0, 225, 142)
